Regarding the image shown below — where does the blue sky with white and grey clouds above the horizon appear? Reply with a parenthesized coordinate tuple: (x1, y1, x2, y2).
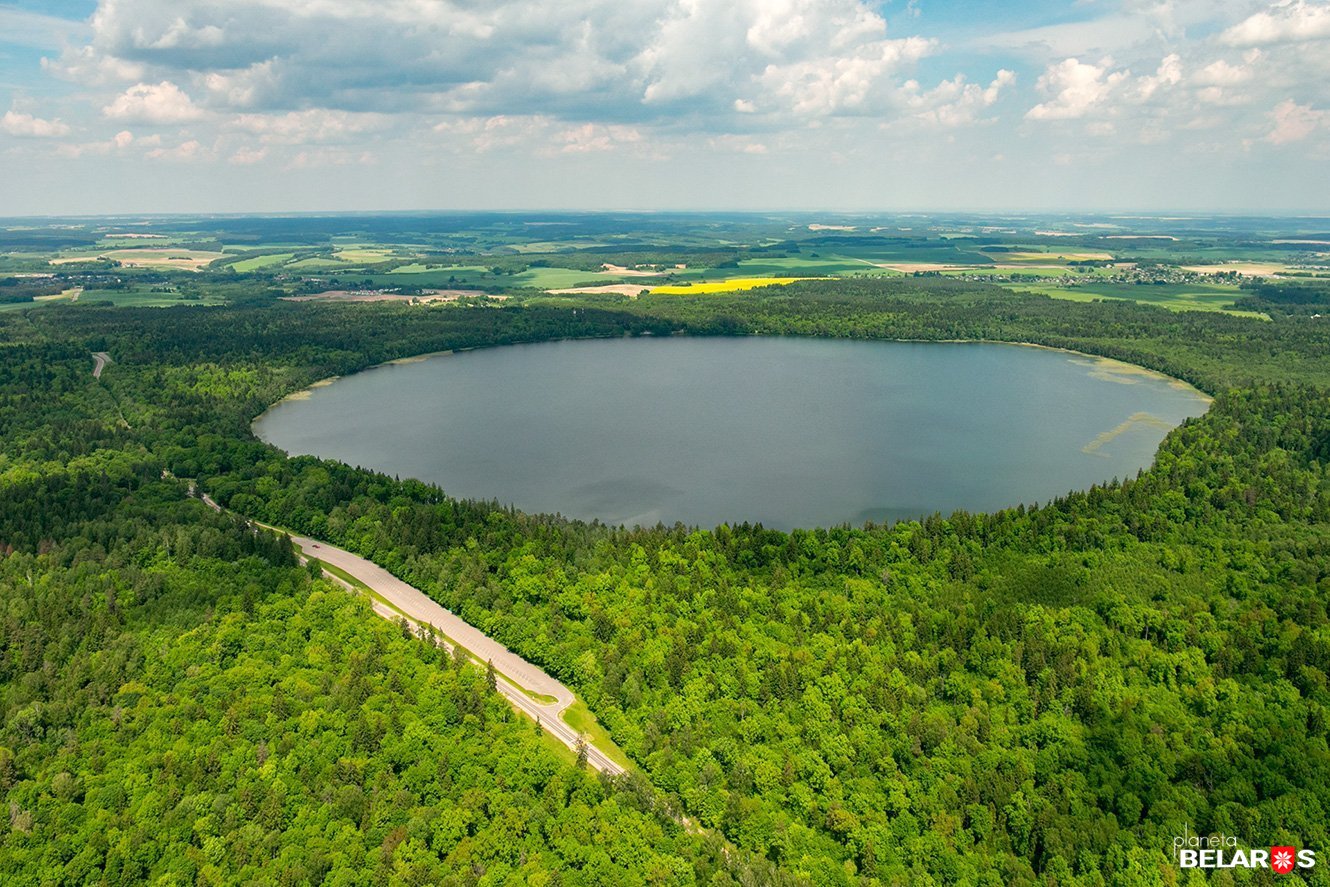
(0, 0, 1330, 215)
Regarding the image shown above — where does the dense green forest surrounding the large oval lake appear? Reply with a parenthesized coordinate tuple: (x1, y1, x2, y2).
(0, 279, 1330, 884)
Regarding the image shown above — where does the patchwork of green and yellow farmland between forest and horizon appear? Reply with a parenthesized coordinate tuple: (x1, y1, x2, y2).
(0, 214, 1330, 313)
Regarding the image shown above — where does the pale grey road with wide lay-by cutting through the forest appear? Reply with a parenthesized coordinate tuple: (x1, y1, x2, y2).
(202, 493, 624, 775)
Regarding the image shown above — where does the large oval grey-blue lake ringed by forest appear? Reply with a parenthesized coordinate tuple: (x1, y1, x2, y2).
(254, 338, 1209, 529)
